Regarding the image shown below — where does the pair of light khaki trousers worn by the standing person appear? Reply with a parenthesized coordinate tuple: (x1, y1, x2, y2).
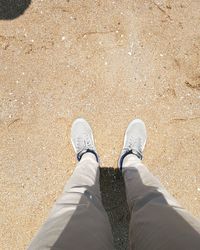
(29, 153, 200, 250)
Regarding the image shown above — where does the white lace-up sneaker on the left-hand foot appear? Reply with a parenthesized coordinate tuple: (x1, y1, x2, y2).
(71, 118, 98, 162)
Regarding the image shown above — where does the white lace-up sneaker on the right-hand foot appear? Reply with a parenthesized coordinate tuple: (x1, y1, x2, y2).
(118, 119, 147, 169)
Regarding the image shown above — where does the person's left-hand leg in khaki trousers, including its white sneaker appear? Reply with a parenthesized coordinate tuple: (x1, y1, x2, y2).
(29, 119, 113, 250)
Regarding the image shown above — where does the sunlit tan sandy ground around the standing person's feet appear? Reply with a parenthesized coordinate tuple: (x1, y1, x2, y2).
(0, 0, 200, 250)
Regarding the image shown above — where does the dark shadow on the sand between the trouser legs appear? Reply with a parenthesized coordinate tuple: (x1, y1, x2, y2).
(100, 168, 130, 250)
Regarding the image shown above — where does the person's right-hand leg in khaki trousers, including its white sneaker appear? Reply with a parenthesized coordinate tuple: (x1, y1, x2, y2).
(120, 120, 200, 250)
